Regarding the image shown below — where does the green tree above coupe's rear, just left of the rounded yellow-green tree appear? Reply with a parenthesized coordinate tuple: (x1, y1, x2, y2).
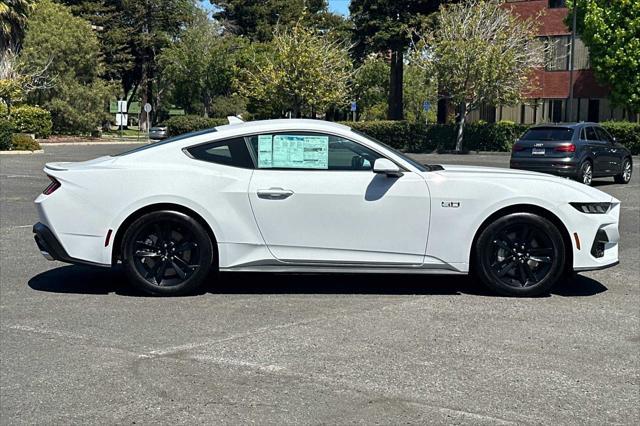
(158, 18, 245, 117)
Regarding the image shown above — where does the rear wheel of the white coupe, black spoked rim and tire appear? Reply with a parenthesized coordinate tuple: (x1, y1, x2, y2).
(122, 210, 214, 296)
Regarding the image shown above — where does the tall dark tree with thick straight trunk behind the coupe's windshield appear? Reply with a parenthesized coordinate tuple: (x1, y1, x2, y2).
(349, 0, 441, 120)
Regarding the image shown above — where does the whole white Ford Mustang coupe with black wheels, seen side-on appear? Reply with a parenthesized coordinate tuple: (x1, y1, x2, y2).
(34, 120, 620, 296)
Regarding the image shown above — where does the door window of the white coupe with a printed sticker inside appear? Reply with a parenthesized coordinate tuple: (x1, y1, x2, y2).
(250, 132, 382, 170)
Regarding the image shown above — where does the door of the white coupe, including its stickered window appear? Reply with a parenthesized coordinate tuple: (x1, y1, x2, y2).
(249, 131, 430, 266)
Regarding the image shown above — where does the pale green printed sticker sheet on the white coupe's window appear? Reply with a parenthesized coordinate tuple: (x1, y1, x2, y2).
(258, 135, 329, 170)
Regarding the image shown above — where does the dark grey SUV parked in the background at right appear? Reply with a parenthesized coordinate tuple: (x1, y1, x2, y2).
(511, 123, 633, 185)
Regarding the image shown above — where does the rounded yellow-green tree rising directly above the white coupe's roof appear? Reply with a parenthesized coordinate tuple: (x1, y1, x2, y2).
(238, 22, 352, 117)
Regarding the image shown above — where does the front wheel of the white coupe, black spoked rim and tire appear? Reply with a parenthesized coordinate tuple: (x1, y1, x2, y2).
(474, 213, 565, 297)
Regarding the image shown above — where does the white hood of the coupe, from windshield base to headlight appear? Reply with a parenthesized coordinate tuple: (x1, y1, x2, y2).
(431, 165, 618, 202)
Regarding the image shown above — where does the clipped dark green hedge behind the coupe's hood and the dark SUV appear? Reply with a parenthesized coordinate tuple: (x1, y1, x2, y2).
(343, 121, 640, 155)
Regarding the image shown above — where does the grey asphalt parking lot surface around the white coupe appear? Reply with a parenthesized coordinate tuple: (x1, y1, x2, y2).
(0, 145, 640, 424)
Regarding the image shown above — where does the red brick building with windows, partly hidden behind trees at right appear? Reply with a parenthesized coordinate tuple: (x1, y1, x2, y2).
(462, 0, 638, 124)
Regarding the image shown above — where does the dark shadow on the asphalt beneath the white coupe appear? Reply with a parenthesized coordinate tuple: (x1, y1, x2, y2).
(28, 265, 607, 297)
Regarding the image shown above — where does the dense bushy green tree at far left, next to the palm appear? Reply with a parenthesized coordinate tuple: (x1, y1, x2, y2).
(20, 0, 111, 132)
